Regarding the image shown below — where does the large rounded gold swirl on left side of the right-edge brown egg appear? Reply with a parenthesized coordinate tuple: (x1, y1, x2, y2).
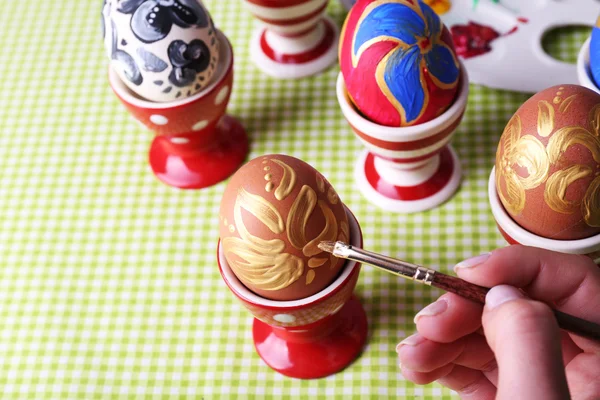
(510, 135, 550, 190)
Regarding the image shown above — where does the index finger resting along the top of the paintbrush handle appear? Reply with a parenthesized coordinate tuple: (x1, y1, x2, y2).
(454, 245, 600, 322)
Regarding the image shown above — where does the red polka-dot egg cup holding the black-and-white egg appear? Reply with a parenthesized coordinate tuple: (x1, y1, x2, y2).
(108, 31, 248, 189)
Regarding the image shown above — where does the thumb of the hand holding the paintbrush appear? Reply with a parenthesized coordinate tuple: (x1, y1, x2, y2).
(483, 285, 570, 400)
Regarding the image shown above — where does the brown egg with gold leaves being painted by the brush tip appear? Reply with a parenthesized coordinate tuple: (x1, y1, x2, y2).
(219, 154, 349, 301)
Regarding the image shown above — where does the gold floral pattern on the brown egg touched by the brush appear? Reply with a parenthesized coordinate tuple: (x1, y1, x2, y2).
(223, 159, 349, 291)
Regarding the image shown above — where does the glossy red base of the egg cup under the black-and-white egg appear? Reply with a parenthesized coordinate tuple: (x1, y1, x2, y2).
(149, 115, 249, 189)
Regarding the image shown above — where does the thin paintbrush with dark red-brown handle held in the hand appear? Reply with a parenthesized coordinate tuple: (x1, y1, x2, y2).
(319, 241, 600, 340)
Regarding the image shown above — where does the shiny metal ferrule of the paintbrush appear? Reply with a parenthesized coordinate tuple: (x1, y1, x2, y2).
(333, 242, 435, 286)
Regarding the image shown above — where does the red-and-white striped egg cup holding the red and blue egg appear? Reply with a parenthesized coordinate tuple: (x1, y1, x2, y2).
(337, 63, 469, 213)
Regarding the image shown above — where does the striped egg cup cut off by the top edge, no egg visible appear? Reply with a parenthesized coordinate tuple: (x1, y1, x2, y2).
(244, 0, 339, 79)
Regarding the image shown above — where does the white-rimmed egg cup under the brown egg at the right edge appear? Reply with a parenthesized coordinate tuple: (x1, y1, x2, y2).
(488, 167, 600, 264)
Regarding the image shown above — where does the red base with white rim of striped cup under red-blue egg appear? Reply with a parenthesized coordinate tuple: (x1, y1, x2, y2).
(355, 146, 462, 213)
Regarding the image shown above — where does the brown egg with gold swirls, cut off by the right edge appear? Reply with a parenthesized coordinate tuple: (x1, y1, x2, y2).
(496, 85, 600, 240)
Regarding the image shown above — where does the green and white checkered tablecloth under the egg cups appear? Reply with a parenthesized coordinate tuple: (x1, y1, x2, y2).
(0, 0, 588, 399)
